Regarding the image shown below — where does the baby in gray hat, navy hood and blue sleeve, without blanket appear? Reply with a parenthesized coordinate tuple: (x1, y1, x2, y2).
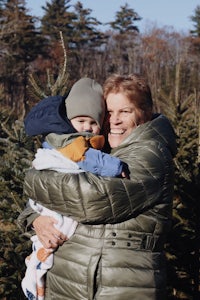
(24, 78, 123, 176)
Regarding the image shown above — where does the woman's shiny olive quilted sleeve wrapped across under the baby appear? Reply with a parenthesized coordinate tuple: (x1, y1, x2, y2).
(24, 142, 173, 224)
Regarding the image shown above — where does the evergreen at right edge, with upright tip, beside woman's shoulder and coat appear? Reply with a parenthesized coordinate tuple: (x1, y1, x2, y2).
(159, 62, 200, 300)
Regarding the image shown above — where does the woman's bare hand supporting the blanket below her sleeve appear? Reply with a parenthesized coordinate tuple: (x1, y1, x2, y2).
(33, 216, 67, 249)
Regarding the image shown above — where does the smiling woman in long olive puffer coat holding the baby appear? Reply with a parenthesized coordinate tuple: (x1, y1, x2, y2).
(19, 75, 176, 300)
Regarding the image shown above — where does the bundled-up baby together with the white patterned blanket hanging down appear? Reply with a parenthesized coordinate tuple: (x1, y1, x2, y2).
(22, 78, 126, 300)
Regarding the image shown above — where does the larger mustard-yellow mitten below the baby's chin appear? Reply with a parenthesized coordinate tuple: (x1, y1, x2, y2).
(57, 136, 89, 162)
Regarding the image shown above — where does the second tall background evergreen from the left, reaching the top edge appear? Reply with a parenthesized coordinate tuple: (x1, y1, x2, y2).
(38, 0, 76, 83)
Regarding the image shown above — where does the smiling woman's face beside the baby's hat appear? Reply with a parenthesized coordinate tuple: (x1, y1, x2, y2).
(106, 93, 144, 148)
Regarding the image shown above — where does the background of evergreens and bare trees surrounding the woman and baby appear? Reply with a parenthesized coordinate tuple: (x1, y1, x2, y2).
(0, 0, 200, 300)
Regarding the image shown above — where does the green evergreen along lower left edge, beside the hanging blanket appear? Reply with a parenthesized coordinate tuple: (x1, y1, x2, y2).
(0, 108, 35, 300)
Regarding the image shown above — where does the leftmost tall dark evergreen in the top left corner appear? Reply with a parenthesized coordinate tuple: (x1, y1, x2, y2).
(0, 0, 44, 113)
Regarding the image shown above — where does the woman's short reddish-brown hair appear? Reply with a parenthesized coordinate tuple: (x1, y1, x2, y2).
(103, 74, 153, 119)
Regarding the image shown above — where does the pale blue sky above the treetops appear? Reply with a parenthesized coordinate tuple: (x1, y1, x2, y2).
(27, 0, 200, 33)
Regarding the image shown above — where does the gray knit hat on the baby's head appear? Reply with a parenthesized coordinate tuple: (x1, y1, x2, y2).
(65, 78, 105, 128)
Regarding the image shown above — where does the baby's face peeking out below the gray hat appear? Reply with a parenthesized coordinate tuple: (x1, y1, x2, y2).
(71, 116, 100, 134)
